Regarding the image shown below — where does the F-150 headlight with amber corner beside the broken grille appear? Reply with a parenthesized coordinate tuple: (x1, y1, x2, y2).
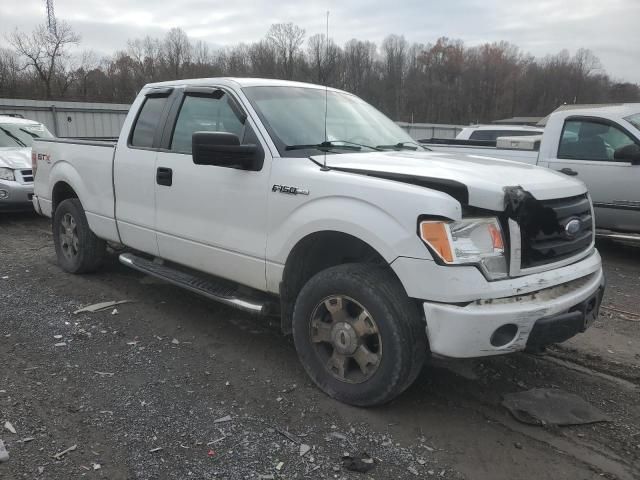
(420, 217, 507, 280)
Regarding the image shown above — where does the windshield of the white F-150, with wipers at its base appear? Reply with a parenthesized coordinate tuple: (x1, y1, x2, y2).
(243, 87, 423, 156)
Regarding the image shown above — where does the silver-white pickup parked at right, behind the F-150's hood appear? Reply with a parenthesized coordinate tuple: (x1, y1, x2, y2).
(426, 103, 640, 243)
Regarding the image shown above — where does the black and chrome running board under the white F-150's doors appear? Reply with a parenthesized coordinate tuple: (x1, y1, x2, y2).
(119, 253, 275, 315)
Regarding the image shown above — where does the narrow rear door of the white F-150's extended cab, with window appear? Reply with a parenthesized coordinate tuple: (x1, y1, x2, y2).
(113, 88, 172, 255)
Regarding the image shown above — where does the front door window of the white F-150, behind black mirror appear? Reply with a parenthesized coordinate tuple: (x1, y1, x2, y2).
(171, 95, 244, 153)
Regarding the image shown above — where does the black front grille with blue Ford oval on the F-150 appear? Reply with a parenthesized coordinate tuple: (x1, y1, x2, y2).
(519, 194, 593, 268)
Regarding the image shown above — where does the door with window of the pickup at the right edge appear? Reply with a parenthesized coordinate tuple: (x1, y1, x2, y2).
(541, 117, 640, 232)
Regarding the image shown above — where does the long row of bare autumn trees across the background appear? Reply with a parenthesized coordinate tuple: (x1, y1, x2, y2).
(0, 21, 640, 124)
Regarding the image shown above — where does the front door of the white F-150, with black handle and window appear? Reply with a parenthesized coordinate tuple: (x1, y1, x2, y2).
(155, 87, 271, 289)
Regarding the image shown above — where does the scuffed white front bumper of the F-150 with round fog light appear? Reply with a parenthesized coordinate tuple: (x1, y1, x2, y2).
(392, 250, 604, 358)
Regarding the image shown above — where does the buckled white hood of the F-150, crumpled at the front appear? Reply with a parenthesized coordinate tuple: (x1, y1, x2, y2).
(311, 151, 587, 211)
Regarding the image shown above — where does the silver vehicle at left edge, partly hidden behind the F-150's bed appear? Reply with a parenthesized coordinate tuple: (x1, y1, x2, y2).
(0, 115, 52, 212)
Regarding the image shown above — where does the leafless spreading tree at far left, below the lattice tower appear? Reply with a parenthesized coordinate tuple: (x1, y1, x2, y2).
(9, 21, 80, 98)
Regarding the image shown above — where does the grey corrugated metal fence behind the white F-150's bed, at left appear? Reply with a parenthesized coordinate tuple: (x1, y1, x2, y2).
(0, 98, 129, 138)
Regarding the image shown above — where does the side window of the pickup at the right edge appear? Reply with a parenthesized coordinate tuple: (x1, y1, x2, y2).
(558, 120, 634, 162)
